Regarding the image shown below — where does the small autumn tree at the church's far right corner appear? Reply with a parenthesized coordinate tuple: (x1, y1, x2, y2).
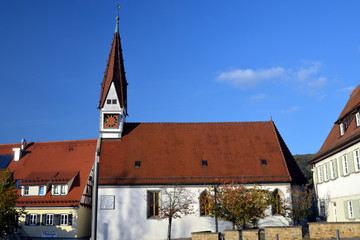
(284, 186, 314, 224)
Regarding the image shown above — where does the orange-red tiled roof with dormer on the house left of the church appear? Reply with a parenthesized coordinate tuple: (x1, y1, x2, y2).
(0, 139, 97, 206)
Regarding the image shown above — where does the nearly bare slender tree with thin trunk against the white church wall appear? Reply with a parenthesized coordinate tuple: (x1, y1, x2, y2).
(160, 186, 194, 240)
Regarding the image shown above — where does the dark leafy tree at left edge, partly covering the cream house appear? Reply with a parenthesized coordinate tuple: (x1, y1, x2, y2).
(0, 169, 24, 238)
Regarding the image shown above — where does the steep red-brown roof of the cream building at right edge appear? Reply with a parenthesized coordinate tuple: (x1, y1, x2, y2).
(309, 85, 360, 164)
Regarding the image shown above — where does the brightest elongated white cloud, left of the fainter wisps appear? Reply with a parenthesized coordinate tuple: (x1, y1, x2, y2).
(217, 67, 285, 88)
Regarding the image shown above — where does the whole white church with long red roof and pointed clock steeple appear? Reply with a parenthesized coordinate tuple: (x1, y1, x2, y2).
(93, 12, 306, 240)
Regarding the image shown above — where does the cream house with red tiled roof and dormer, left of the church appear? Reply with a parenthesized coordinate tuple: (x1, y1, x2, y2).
(0, 139, 96, 239)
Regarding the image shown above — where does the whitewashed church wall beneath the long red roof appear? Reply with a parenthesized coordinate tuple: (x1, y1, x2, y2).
(97, 183, 290, 240)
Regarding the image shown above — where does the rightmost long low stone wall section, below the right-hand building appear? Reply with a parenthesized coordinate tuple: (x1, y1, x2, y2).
(309, 222, 360, 239)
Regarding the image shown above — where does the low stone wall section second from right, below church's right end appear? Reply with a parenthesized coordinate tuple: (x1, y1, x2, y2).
(265, 226, 302, 240)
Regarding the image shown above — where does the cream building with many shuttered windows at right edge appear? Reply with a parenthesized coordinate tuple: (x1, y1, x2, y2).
(310, 85, 360, 222)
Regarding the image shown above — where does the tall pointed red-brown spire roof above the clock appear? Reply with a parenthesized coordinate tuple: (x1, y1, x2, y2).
(98, 6, 128, 109)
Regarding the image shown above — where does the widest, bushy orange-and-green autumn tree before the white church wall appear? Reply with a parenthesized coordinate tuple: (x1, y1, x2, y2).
(202, 182, 271, 229)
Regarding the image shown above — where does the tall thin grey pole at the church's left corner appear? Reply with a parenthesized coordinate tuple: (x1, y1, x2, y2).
(91, 137, 101, 240)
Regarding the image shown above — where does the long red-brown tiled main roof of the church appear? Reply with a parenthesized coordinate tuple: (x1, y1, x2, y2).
(99, 121, 304, 185)
